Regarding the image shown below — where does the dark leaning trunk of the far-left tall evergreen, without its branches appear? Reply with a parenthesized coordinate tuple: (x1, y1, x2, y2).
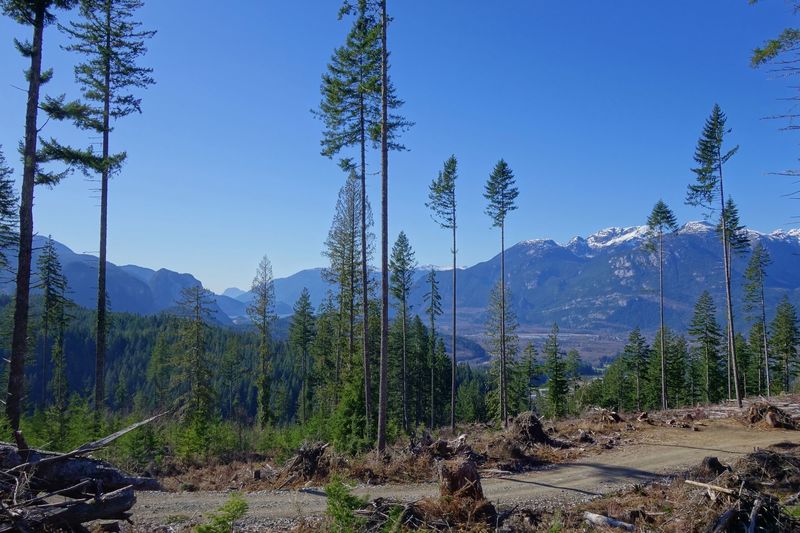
(6, 2, 45, 430)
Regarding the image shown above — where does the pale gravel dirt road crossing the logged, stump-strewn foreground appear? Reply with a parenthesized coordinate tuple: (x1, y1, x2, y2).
(133, 421, 800, 530)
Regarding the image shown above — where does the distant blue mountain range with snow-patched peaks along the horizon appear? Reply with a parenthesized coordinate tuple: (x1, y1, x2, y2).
(3, 222, 800, 335)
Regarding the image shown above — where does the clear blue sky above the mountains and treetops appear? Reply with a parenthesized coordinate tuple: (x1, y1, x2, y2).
(0, 0, 800, 291)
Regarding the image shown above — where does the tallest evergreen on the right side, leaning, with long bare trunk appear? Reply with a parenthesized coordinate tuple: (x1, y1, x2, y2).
(686, 104, 742, 407)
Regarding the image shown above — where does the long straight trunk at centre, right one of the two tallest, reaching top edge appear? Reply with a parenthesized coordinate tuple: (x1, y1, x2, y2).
(378, 0, 389, 452)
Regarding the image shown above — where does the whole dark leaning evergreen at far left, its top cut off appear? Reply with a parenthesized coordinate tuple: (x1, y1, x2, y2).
(0, 0, 77, 430)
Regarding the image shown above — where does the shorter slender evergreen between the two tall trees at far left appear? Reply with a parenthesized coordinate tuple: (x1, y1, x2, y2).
(37, 237, 67, 408)
